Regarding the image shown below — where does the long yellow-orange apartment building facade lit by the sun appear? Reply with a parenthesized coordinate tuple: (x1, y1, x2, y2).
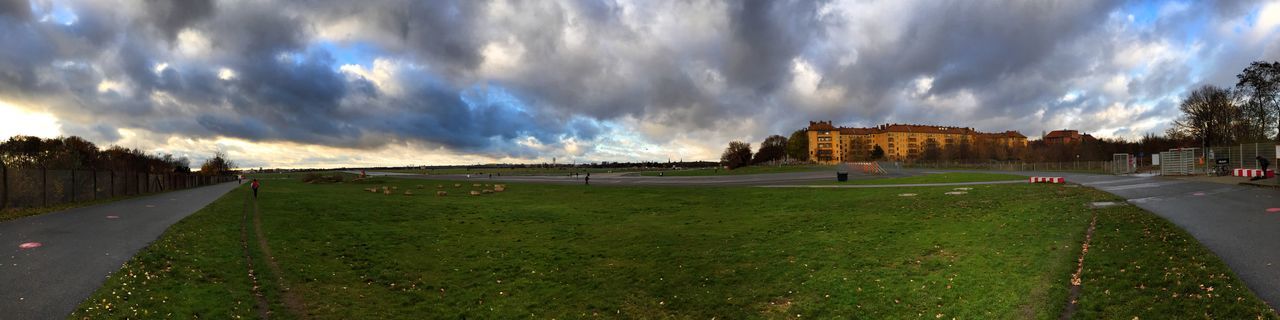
(808, 122, 1027, 163)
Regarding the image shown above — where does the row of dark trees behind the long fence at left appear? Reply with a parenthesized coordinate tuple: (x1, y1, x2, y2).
(0, 136, 236, 175)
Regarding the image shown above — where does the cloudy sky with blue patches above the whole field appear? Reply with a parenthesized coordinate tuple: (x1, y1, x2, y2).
(0, 0, 1280, 168)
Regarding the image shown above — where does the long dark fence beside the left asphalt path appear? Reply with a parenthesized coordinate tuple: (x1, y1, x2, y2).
(0, 166, 236, 210)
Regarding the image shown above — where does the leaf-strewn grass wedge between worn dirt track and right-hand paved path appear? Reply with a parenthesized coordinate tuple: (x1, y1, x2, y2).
(1079, 200, 1276, 319)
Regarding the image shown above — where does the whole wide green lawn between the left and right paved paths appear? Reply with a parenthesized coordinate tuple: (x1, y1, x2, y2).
(72, 174, 1276, 319)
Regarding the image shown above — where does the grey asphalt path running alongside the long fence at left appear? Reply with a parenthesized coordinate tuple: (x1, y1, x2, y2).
(0, 183, 238, 319)
